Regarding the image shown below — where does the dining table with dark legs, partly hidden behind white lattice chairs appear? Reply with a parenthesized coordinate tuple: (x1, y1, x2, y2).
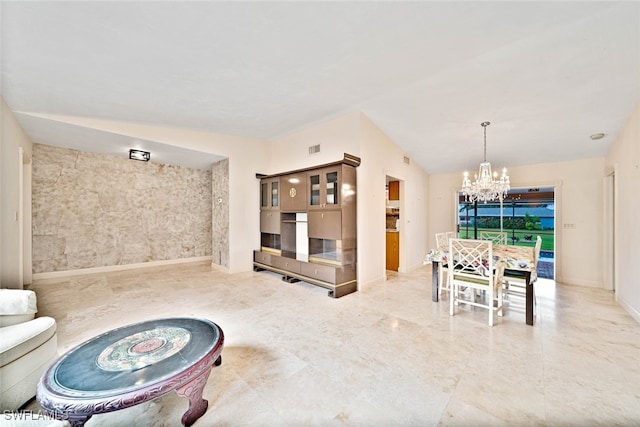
(424, 244, 537, 325)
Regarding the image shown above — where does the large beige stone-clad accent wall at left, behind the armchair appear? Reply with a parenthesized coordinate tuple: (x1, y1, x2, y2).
(32, 144, 212, 273)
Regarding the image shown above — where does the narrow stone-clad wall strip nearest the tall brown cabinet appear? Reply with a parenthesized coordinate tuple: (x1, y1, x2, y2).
(211, 159, 229, 268)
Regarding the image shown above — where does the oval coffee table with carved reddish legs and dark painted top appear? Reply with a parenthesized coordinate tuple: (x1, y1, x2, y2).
(36, 318, 224, 427)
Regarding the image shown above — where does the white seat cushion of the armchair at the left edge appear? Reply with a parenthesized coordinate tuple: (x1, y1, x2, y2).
(0, 316, 57, 367)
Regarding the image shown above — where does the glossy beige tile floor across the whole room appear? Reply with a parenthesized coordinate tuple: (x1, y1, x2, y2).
(20, 263, 640, 427)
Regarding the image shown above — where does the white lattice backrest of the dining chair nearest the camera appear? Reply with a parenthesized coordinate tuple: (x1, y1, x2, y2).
(449, 239, 501, 286)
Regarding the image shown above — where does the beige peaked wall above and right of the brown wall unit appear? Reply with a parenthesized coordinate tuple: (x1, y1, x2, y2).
(266, 112, 428, 288)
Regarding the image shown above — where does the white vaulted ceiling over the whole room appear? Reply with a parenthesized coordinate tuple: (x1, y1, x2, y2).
(0, 1, 640, 173)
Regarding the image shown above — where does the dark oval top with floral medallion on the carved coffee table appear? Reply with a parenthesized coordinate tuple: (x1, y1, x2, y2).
(44, 318, 221, 397)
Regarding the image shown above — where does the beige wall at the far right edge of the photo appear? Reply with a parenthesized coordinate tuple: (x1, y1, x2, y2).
(606, 101, 640, 321)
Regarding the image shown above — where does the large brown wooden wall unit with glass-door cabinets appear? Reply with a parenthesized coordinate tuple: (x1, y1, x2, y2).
(253, 154, 360, 298)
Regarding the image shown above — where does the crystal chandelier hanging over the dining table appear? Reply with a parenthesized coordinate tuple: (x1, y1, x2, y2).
(461, 122, 510, 203)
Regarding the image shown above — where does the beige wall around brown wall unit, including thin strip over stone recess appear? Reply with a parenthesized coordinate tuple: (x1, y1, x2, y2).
(16, 112, 428, 284)
